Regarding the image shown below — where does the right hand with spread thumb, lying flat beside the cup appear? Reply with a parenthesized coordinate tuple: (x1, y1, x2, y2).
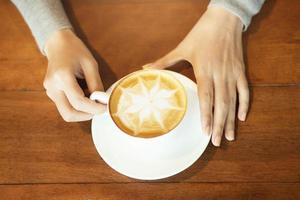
(144, 6, 249, 146)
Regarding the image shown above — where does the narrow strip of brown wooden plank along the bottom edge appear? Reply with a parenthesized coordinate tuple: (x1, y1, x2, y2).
(0, 183, 300, 200)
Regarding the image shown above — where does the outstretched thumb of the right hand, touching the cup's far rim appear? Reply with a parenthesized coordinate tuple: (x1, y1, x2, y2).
(143, 49, 184, 69)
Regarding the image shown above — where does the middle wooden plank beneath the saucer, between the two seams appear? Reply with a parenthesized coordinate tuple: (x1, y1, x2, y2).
(0, 87, 300, 184)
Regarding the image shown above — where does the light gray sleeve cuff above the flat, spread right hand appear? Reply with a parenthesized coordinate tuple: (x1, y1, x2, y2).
(209, 0, 265, 31)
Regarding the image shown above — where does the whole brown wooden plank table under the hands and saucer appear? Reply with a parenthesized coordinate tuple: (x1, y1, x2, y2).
(0, 0, 300, 200)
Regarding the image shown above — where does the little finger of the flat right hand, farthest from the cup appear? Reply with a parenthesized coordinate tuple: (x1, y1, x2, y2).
(237, 74, 249, 121)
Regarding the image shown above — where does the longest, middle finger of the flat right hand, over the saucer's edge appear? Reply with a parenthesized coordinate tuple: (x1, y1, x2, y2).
(212, 80, 228, 146)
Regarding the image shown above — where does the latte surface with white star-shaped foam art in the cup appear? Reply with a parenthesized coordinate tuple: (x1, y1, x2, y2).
(108, 70, 187, 138)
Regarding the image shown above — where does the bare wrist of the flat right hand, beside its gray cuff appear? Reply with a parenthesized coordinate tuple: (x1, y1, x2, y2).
(205, 6, 243, 32)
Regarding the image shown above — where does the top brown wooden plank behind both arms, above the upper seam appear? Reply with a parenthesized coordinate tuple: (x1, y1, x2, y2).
(0, 0, 300, 90)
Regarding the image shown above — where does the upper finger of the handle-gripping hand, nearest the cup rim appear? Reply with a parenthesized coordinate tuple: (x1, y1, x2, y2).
(81, 58, 103, 93)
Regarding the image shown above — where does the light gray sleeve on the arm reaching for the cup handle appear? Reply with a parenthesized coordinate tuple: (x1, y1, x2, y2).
(11, 0, 72, 54)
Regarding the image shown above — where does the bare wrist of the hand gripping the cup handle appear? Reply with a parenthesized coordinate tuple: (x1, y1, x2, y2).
(44, 29, 76, 57)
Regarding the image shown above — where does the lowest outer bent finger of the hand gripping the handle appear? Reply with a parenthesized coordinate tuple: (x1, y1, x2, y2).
(46, 90, 93, 122)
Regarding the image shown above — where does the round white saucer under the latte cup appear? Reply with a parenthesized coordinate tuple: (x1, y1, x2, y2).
(92, 71, 210, 180)
